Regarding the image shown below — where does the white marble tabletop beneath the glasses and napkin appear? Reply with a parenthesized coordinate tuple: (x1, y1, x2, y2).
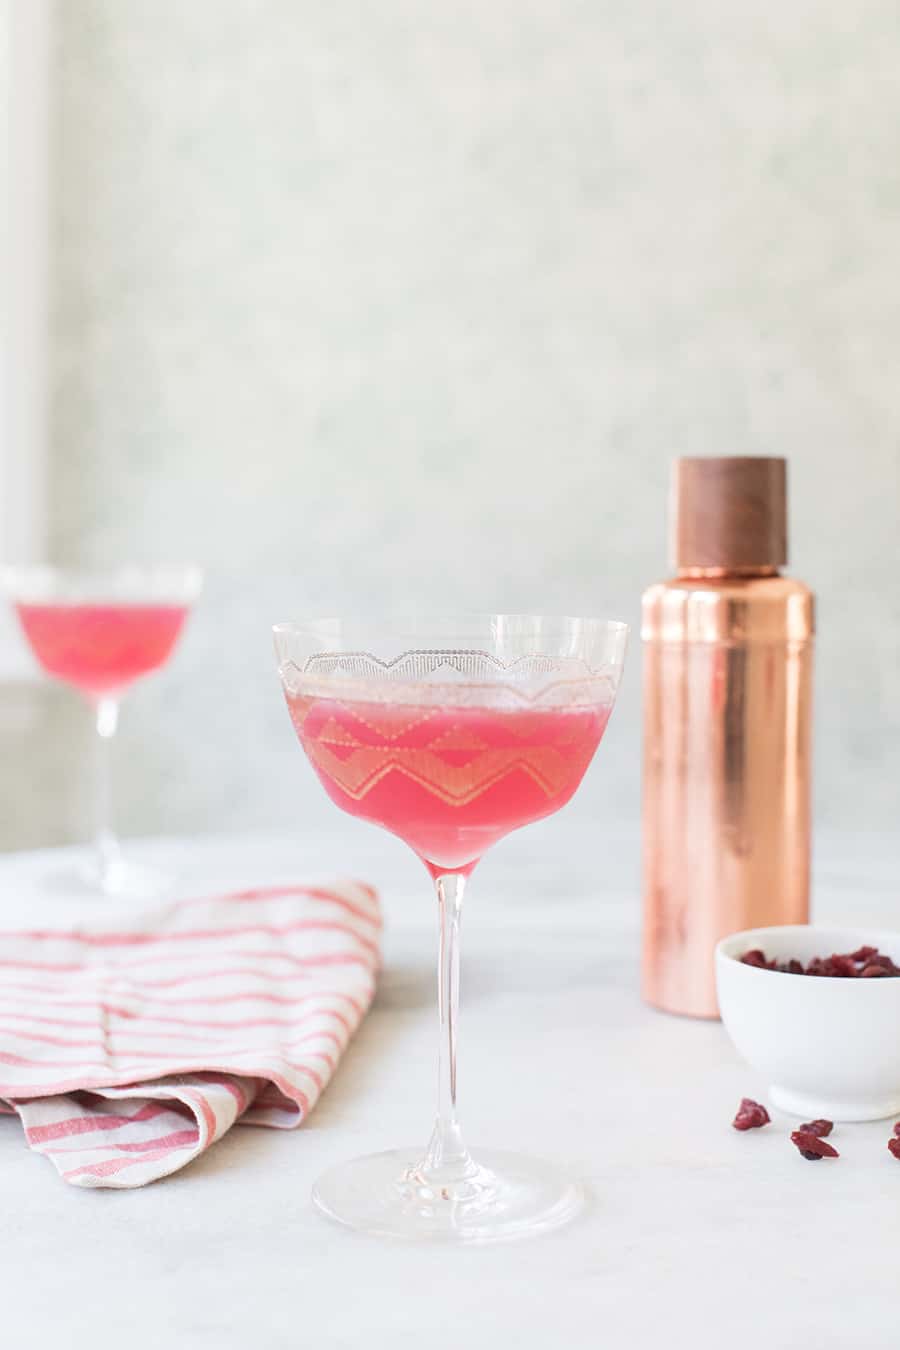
(0, 817, 900, 1350)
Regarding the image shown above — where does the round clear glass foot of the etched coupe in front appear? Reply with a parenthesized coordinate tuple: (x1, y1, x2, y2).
(313, 1149, 584, 1243)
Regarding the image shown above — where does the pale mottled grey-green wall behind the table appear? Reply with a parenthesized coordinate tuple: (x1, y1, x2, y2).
(0, 0, 900, 848)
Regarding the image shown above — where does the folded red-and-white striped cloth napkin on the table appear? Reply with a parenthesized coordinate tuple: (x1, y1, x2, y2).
(0, 882, 381, 1187)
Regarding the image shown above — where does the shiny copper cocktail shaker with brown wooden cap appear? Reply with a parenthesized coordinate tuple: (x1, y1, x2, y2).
(642, 458, 814, 1017)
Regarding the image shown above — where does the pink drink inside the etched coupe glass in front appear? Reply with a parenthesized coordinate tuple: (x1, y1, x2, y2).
(287, 694, 610, 875)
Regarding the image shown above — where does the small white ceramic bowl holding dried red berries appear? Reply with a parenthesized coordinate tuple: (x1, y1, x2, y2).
(715, 925, 900, 1121)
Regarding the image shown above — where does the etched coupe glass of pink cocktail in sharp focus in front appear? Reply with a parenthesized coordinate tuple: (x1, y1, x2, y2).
(274, 614, 627, 1242)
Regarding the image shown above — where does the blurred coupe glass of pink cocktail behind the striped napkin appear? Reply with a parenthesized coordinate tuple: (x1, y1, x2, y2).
(0, 567, 201, 895)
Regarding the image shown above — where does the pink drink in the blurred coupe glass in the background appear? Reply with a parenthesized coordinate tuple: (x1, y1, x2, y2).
(16, 602, 188, 698)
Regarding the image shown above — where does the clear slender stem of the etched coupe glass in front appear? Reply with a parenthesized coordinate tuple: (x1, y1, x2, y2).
(424, 873, 475, 1180)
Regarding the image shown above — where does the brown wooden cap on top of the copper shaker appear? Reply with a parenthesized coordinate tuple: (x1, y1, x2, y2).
(673, 456, 788, 571)
